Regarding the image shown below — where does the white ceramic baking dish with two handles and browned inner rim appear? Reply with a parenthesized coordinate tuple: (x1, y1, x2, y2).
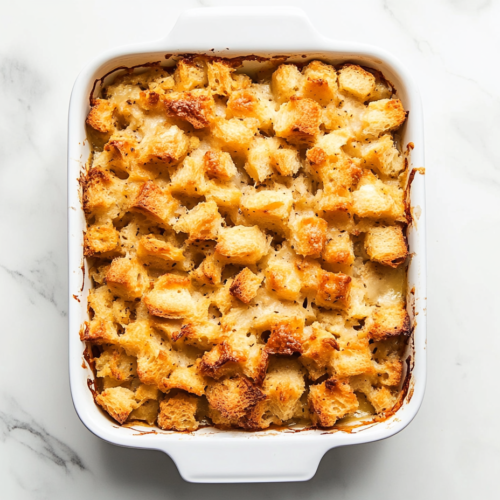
(68, 7, 426, 482)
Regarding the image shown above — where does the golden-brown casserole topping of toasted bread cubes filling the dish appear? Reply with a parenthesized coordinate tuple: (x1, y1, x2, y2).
(80, 57, 410, 431)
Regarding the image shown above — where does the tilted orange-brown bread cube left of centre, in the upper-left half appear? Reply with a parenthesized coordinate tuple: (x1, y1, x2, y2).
(130, 181, 179, 227)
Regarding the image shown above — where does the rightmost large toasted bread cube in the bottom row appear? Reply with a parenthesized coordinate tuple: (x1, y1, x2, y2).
(308, 377, 358, 427)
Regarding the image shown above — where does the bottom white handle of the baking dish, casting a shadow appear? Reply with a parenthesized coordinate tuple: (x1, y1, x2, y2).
(166, 433, 335, 483)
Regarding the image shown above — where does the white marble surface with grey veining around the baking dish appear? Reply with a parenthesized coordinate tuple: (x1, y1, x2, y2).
(0, 0, 500, 500)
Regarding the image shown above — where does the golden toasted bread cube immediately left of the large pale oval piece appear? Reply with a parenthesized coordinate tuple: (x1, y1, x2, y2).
(106, 257, 149, 300)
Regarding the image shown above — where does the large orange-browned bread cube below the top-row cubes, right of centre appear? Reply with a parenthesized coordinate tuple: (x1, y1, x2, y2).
(274, 96, 321, 144)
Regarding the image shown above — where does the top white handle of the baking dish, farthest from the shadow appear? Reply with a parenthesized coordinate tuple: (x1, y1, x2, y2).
(163, 7, 323, 54)
